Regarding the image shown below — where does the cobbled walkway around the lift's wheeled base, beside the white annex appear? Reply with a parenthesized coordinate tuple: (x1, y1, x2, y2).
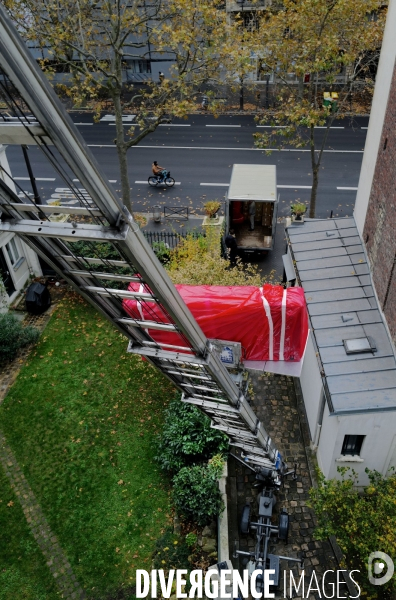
(227, 373, 338, 600)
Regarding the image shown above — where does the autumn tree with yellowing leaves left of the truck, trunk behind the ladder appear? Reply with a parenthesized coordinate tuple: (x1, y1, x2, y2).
(5, 0, 234, 210)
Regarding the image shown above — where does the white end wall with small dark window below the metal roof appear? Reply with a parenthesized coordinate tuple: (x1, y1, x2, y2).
(318, 406, 396, 486)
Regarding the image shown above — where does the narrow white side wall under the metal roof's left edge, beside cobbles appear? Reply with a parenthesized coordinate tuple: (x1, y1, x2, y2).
(300, 331, 323, 440)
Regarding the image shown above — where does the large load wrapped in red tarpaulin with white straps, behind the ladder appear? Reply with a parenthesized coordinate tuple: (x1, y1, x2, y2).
(123, 283, 308, 361)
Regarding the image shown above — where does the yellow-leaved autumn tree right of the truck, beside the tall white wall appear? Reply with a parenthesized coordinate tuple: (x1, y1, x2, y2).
(250, 0, 385, 217)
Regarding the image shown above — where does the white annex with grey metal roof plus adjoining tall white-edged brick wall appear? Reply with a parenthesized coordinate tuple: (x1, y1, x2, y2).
(288, 0, 396, 486)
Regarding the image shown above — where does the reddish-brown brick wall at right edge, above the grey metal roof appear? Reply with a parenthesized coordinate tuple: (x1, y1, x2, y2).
(363, 65, 396, 343)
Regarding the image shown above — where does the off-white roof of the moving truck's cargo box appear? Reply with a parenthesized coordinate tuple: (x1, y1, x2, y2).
(227, 164, 277, 202)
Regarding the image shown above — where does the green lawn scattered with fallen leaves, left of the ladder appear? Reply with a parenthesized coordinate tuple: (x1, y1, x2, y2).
(0, 295, 174, 599)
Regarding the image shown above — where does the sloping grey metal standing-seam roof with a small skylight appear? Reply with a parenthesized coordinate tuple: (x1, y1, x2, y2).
(287, 217, 396, 415)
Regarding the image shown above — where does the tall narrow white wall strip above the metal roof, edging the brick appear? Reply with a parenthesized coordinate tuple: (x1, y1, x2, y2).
(354, 0, 396, 235)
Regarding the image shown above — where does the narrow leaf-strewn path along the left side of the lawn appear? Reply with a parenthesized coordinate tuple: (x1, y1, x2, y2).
(0, 289, 86, 600)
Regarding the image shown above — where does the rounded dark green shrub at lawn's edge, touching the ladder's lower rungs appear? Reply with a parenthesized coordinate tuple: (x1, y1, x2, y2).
(157, 397, 228, 472)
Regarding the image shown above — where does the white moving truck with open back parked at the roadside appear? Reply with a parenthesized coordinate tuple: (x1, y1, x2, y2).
(225, 165, 279, 253)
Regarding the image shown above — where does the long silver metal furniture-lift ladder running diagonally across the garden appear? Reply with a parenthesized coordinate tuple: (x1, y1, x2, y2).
(0, 6, 277, 472)
